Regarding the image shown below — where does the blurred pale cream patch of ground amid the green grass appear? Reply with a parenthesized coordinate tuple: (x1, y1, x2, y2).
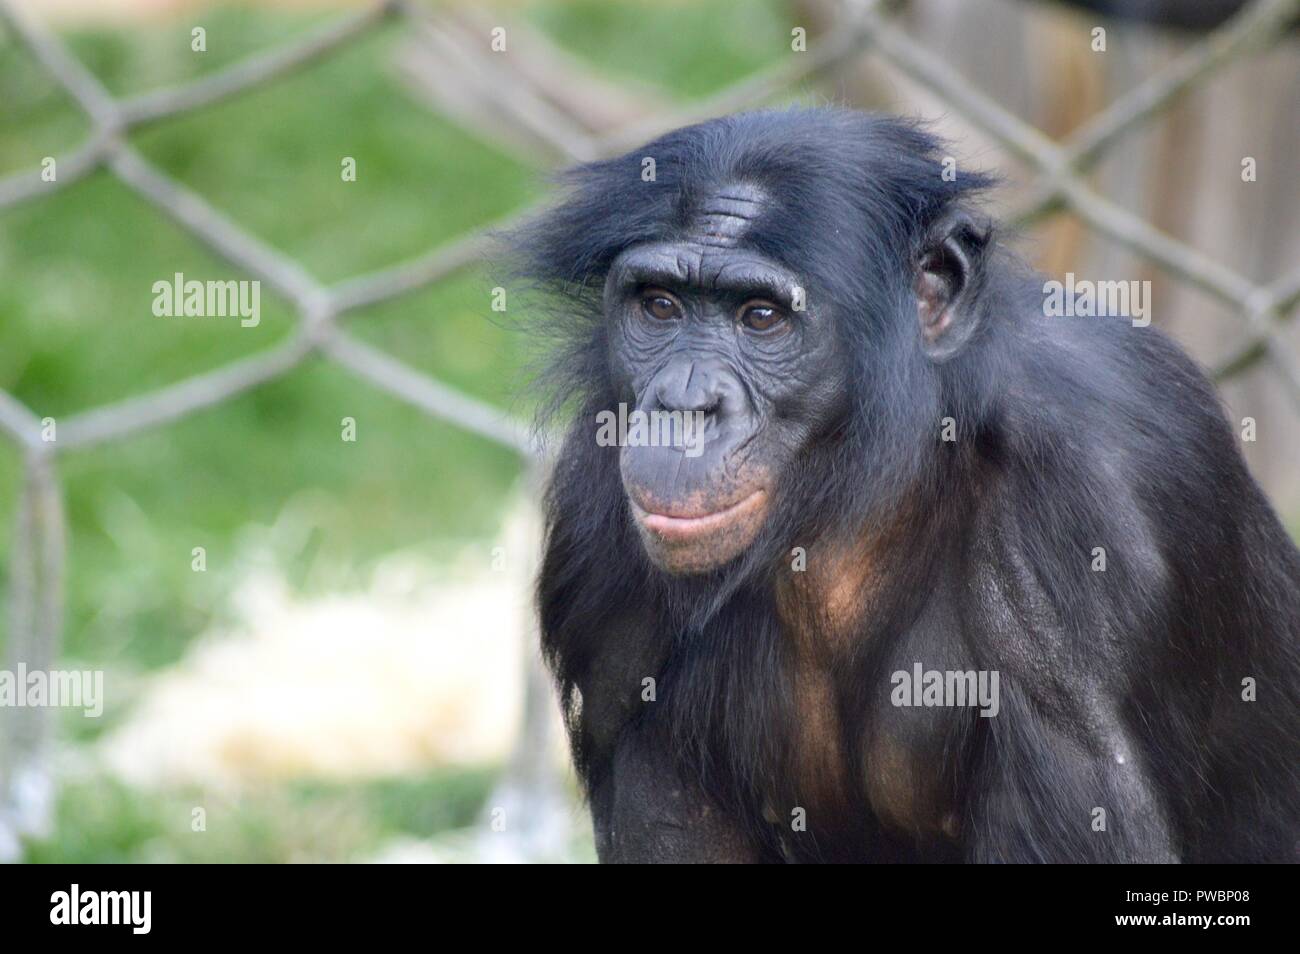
(96, 504, 537, 786)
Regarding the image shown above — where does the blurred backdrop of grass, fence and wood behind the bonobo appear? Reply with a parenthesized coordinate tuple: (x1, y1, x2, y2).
(0, 0, 1300, 862)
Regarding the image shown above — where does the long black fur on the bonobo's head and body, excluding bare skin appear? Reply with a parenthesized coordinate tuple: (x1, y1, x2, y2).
(514, 109, 1300, 862)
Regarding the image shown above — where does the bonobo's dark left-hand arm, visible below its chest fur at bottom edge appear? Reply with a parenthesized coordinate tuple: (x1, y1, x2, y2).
(592, 730, 766, 864)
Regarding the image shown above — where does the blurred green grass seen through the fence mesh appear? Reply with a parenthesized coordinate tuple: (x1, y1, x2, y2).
(0, 0, 789, 860)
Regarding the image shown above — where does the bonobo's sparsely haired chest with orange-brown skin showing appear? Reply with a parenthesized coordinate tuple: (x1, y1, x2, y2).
(777, 547, 970, 842)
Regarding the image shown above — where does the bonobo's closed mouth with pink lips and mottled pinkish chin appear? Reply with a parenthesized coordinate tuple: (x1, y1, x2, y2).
(628, 487, 768, 573)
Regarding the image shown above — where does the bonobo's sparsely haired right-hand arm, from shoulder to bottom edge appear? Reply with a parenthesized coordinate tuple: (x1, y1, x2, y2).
(965, 527, 1180, 863)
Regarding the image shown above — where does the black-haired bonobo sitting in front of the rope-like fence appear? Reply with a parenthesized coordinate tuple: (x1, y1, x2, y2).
(511, 109, 1300, 862)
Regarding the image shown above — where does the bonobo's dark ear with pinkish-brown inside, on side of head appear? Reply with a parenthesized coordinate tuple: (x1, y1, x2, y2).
(913, 212, 991, 361)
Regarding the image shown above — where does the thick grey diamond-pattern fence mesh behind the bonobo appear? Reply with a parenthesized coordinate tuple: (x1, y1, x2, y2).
(0, 0, 1300, 858)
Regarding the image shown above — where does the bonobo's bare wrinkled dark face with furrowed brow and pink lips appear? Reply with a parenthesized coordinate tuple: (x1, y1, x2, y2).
(605, 185, 846, 573)
